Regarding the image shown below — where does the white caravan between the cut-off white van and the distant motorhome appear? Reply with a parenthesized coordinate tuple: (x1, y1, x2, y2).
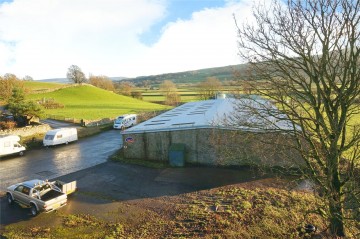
(43, 128, 78, 146)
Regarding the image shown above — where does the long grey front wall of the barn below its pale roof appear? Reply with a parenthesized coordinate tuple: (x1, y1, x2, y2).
(123, 129, 300, 167)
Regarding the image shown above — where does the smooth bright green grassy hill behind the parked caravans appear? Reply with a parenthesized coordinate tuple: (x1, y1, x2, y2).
(28, 85, 166, 119)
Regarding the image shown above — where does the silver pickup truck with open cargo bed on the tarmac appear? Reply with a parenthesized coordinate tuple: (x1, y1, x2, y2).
(6, 179, 76, 216)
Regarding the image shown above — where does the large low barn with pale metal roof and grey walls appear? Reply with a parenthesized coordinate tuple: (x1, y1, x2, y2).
(122, 98, 300, 166)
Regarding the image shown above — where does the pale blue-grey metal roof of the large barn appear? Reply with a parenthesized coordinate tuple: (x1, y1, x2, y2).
(122, 98, 292, 134)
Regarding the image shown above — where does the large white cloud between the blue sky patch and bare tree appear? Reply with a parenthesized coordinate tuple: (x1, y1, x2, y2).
(131, 1, 255, 74)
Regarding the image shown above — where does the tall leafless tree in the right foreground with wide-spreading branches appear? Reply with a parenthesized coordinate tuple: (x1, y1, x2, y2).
(235, 0, 360, 237)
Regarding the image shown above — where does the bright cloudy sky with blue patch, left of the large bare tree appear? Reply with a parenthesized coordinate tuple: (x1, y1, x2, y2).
(0, 0, 253, 80)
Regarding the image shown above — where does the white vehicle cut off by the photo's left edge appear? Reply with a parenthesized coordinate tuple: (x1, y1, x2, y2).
(0, 135, 26, 157)
